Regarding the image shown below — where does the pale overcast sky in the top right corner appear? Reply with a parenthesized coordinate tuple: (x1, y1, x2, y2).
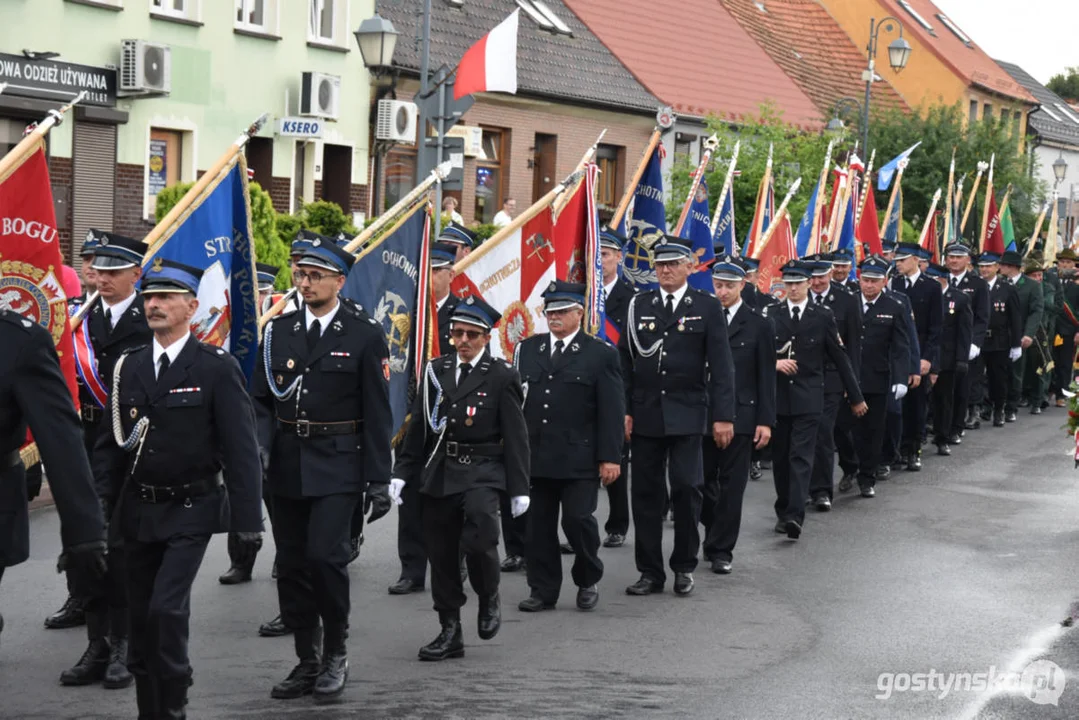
(934, 0, 1079, 83)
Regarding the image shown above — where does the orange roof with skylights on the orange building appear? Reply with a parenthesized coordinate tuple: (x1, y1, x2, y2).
(877, 0, 1037, 105)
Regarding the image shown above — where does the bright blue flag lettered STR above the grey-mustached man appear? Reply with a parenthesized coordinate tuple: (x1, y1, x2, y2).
(144, 153, 259, 378)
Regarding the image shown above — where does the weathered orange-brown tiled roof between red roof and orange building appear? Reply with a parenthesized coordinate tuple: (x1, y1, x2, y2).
(720, 0, 909, 117)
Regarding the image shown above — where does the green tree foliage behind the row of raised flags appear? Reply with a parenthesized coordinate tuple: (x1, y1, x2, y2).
(667, 105, 1046, 252)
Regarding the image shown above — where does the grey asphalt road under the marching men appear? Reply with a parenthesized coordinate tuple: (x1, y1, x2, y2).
(0, 409, 1079, 720)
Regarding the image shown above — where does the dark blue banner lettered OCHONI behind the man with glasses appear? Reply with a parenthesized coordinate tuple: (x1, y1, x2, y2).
(341, 203, 431, 431)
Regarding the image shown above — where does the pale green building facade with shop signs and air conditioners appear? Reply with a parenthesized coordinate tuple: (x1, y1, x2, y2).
(0, 0, 373, 261)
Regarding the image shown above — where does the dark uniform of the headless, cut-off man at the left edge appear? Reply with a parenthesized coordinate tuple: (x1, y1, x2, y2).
(0, 310, 105, 643)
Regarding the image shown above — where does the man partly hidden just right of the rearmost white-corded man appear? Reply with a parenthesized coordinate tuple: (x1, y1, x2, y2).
(805, 255, 862, 512)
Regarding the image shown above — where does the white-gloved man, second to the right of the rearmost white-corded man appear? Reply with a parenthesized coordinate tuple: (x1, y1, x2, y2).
(855, 255, 913, 498)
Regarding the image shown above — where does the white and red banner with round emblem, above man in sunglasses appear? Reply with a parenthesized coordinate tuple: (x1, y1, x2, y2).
(450, 207, 555, 358)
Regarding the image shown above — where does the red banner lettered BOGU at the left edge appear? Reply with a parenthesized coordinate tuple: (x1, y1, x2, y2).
(0, 144, 79, 403)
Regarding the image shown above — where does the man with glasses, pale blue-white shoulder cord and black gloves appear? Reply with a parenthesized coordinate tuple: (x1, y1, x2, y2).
(252, 237, 392, 699)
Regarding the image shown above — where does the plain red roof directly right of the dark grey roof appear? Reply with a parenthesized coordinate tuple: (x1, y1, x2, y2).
(564, 0, 823, 130)
